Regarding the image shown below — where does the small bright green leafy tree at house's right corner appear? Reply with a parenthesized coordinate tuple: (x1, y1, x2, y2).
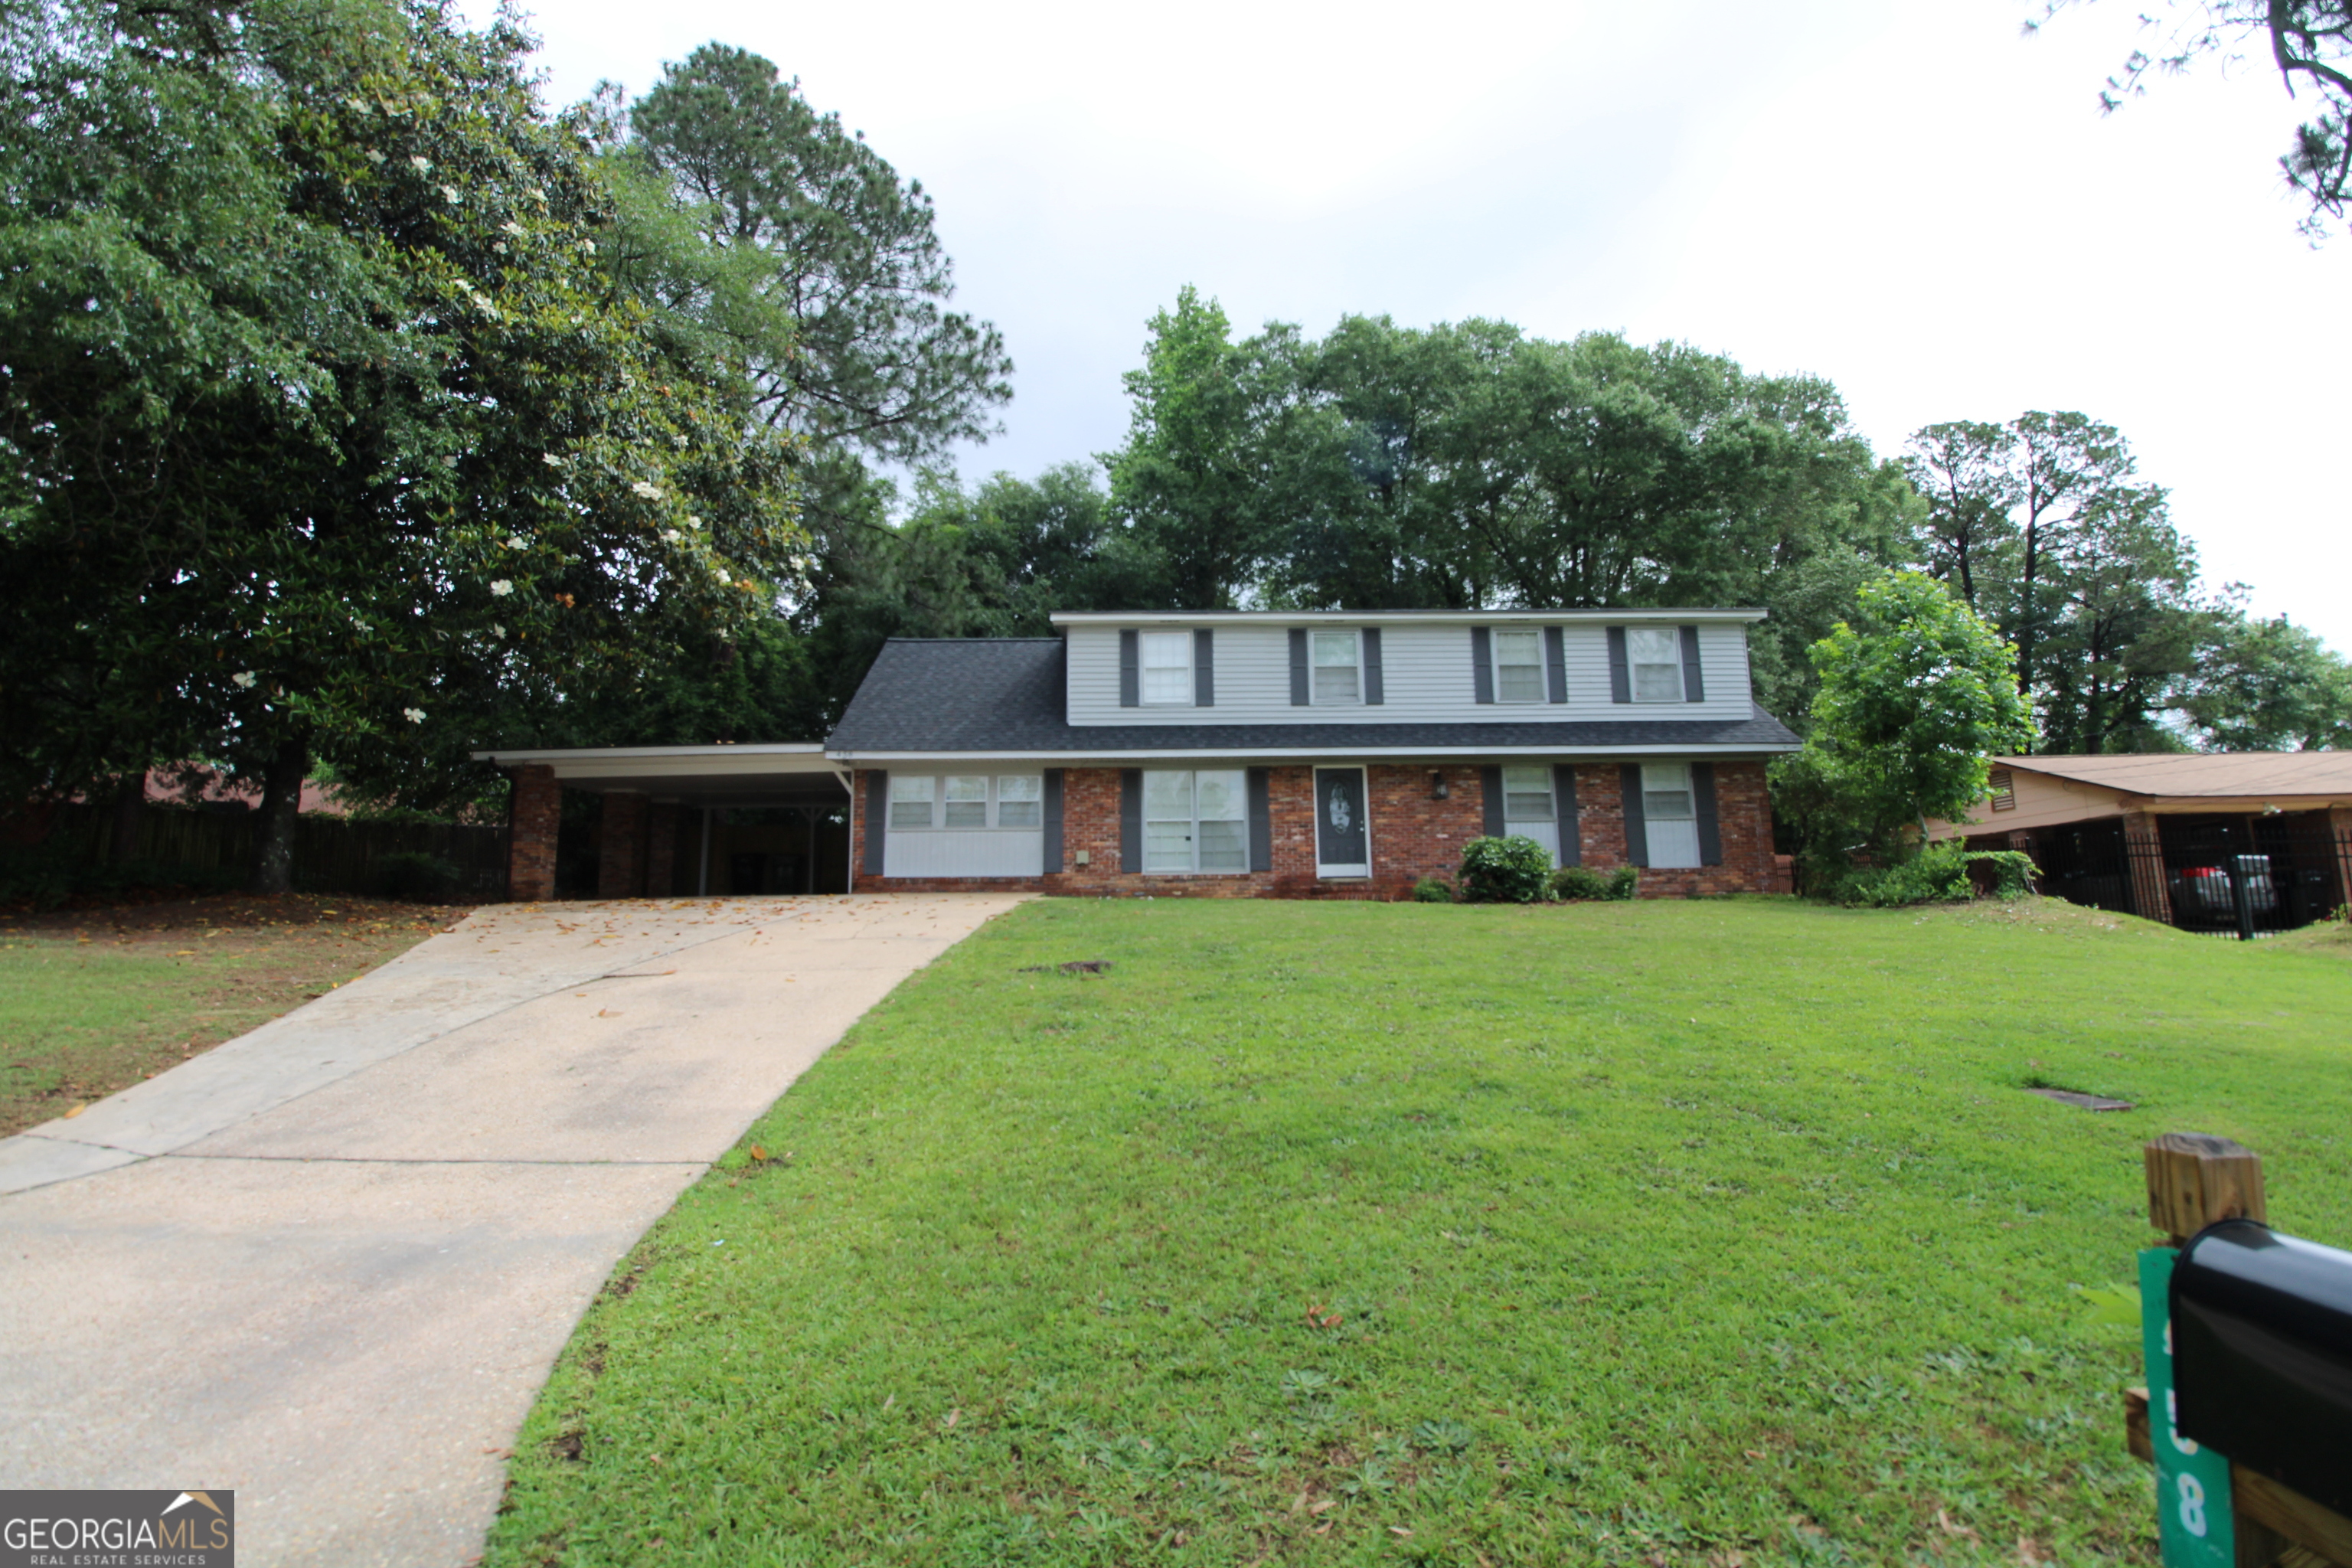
(1773, 571, 2034, 863)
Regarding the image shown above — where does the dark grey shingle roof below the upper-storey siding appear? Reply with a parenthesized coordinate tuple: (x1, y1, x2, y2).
(825, 637, 1797, 755)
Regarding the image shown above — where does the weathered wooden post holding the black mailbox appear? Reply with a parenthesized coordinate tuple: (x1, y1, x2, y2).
(2124, 1133, 2352, 1568)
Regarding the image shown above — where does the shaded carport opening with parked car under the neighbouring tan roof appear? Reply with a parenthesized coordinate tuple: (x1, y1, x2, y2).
(2030, 828, 2352, 940)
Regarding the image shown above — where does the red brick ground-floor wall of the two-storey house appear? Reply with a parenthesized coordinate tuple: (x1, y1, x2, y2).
(851, 762, 1781, 898)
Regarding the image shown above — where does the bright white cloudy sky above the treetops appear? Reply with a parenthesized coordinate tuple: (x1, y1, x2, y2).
(475, 0, 2352, 652)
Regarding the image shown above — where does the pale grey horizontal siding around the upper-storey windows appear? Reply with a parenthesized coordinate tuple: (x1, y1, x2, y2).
(1068, 616, 1753, 727)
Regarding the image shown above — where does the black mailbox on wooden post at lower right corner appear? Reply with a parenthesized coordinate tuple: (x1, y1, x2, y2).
(2171, 1220, 2352, 1514)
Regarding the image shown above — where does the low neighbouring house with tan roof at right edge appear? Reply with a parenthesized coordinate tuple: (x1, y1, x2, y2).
(1929, 753, 2352, 926)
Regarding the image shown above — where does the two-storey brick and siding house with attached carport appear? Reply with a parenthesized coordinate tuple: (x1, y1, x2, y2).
(485, 609, 1797, 898)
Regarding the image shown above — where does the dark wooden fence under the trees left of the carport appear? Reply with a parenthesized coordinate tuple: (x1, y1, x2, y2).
(50, 804, 505, 900)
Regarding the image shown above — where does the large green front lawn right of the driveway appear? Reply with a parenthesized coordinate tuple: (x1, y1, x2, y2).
(489, 900, 2352, 1566)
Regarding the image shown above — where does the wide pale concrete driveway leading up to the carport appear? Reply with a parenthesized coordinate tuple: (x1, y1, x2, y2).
(0, 893, 1021, 1568)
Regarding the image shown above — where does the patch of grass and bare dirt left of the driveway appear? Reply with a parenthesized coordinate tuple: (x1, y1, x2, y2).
(0, 893, 466, 1135)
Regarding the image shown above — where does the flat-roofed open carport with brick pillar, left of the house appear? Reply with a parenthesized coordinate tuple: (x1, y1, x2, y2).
(472, 743, 854, 900)
